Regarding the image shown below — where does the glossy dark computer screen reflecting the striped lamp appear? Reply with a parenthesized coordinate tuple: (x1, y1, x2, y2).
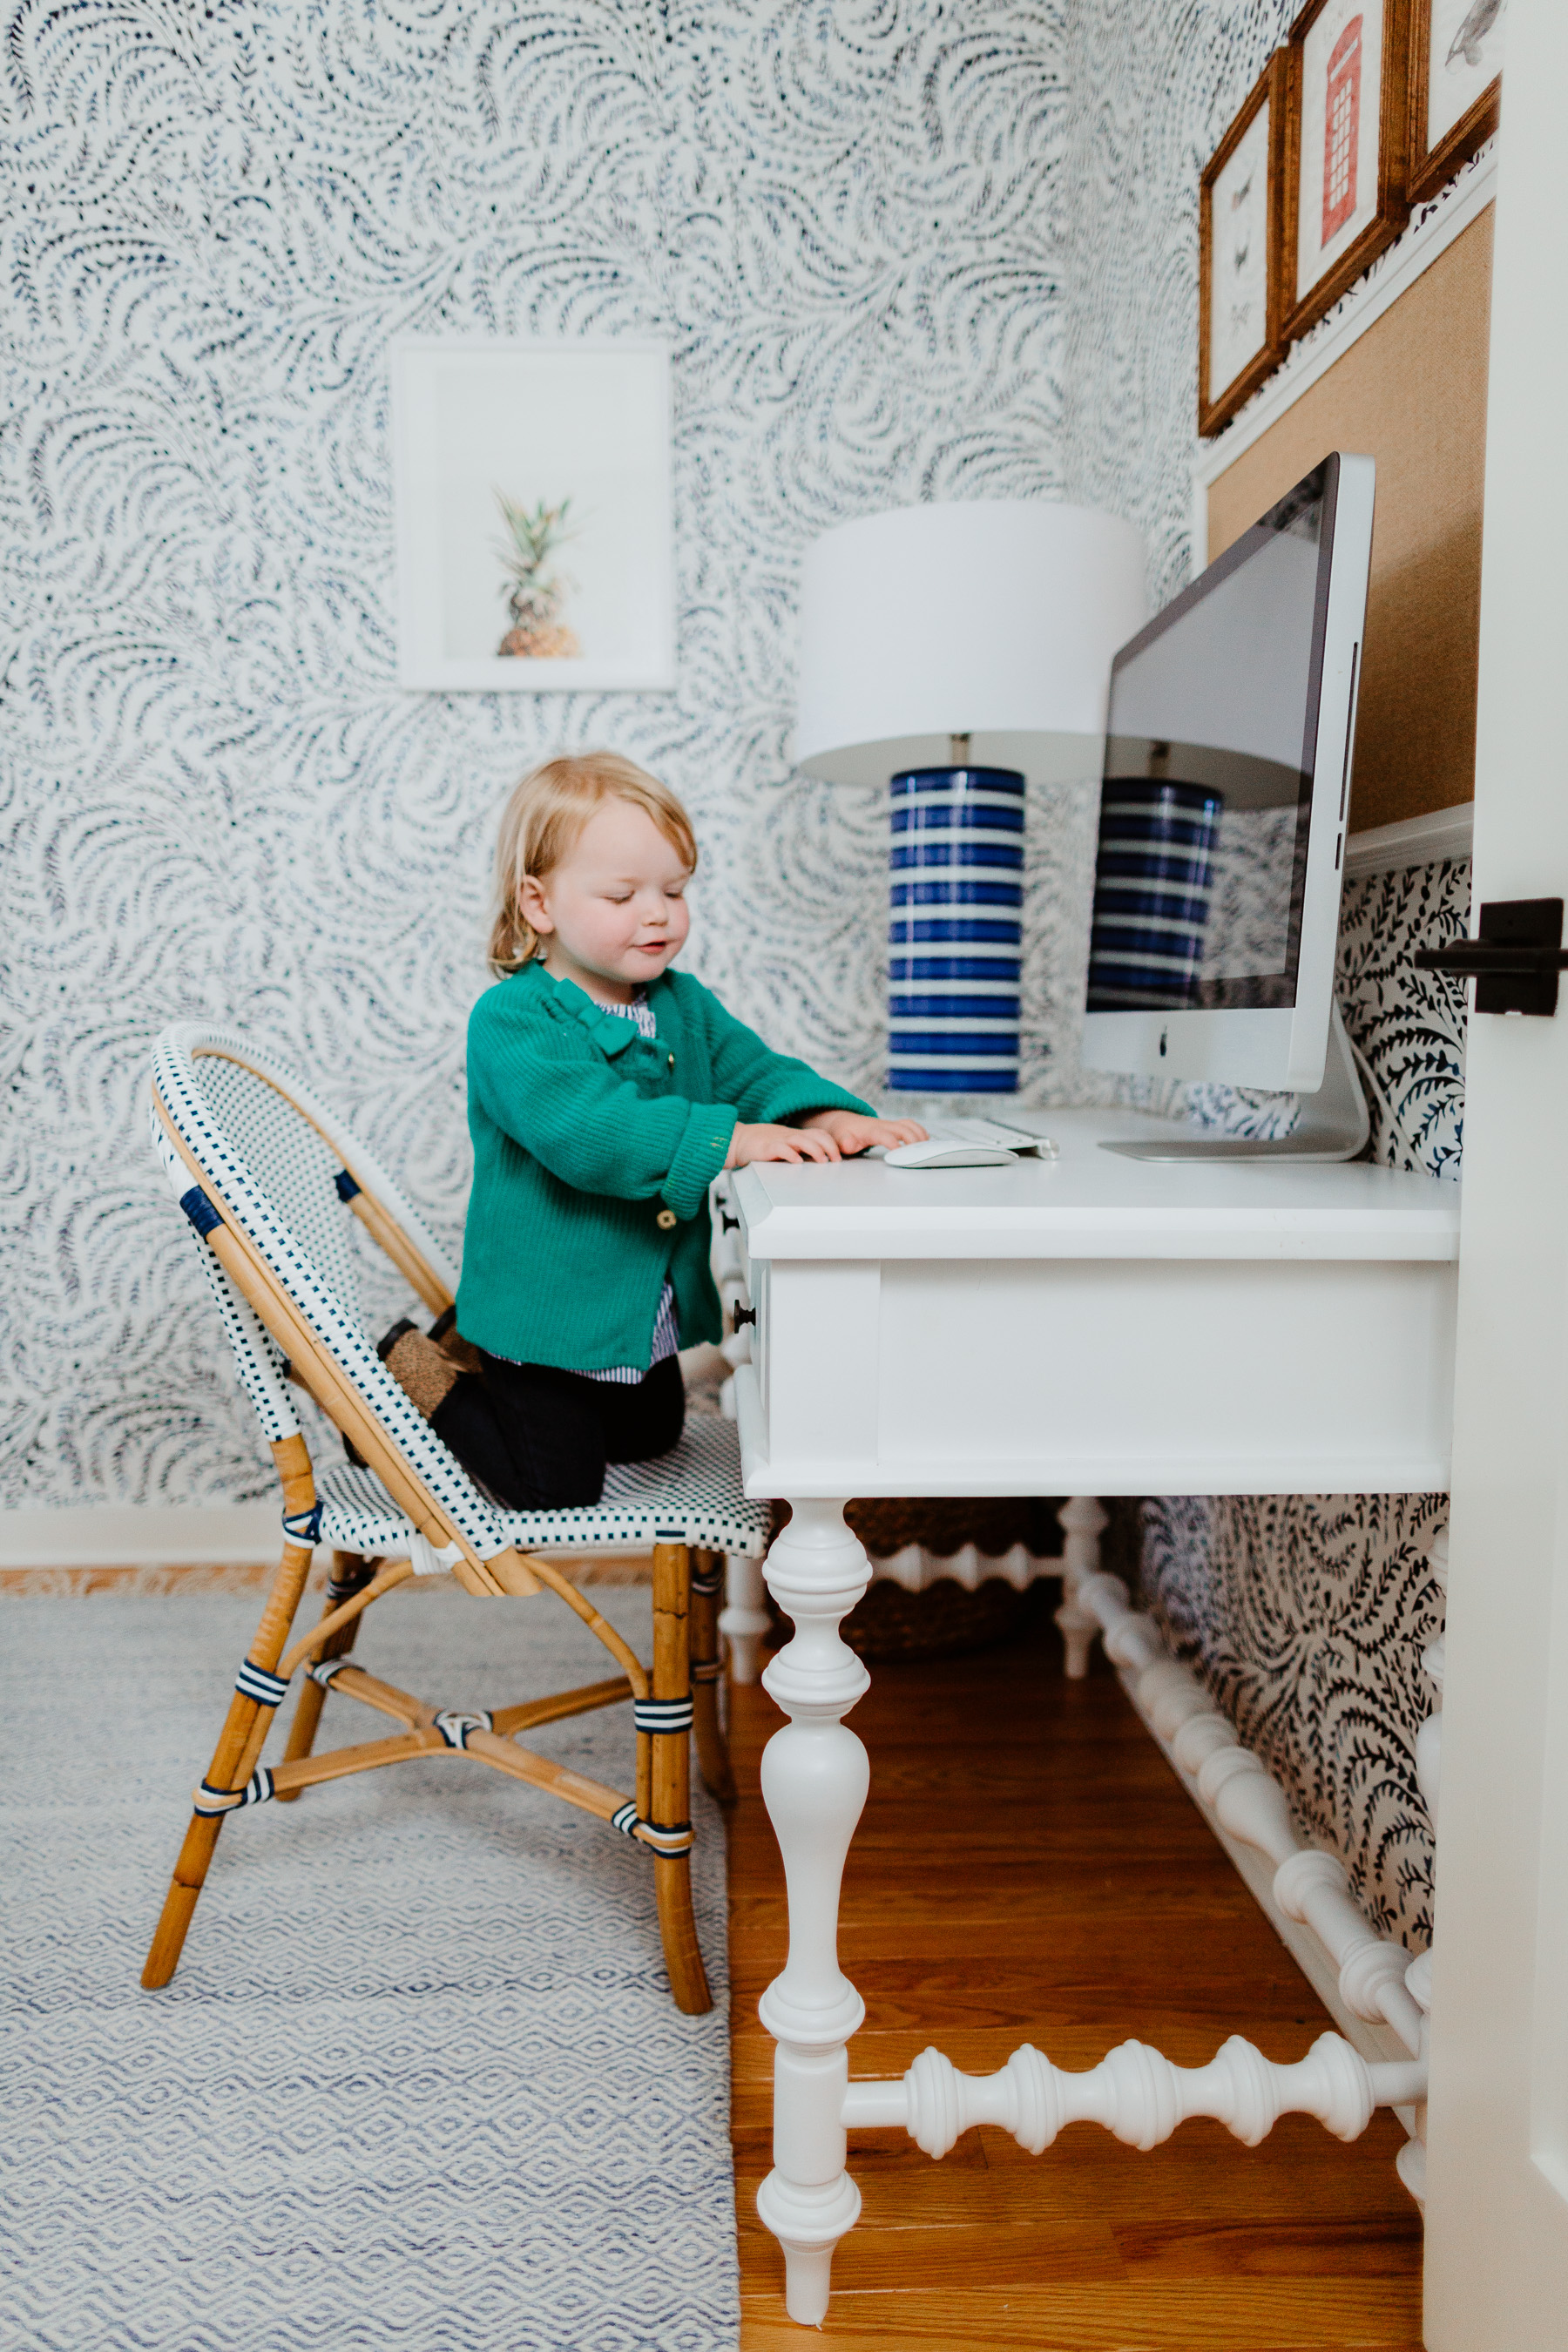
(1086, 459, 1354, 1014)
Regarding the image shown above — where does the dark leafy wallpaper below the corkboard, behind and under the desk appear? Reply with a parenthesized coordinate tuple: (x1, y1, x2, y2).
(1143, 863, 1470, 1950)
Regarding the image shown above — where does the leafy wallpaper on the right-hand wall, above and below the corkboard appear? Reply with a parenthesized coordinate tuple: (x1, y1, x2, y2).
(1056, 0, 1470, 1950)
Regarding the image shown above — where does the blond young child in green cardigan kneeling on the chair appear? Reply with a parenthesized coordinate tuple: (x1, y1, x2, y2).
(433, 753, 924, 1510)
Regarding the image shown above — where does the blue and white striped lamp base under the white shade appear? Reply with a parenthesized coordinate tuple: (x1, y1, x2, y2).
(889, 767, 1023, 1094)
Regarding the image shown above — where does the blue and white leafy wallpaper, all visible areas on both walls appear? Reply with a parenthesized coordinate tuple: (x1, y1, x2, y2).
(0, 0, 1467, 1943)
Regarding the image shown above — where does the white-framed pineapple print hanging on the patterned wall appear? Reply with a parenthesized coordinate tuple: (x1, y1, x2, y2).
(393, 336, 675, 694)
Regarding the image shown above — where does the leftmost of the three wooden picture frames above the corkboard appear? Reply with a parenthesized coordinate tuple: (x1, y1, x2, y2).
(1199, 50, 1286, 437)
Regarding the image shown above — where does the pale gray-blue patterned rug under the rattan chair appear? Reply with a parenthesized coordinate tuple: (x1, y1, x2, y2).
(0, 1585, 738, 2352)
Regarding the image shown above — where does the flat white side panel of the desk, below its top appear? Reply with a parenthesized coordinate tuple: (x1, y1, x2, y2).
(747, 1259, 1457, 1494)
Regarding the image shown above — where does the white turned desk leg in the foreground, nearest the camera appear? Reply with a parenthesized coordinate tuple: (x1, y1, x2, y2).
(757, 1501, 870, 2326)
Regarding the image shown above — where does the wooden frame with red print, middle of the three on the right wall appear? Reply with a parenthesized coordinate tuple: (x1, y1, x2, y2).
(1281, 0, 1410, 343)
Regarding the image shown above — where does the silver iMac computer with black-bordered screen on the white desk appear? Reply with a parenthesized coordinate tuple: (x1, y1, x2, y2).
(1084, 454, 1375, 1159)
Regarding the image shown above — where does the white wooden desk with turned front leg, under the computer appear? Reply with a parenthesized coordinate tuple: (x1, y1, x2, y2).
(731, 1110, 1460, 2322)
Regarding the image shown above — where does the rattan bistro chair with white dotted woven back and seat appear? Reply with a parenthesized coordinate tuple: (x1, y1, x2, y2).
(141, 1024, 768, 2013)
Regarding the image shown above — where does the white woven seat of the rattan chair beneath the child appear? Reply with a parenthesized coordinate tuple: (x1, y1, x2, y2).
(315, 1414, 771, 1559)
